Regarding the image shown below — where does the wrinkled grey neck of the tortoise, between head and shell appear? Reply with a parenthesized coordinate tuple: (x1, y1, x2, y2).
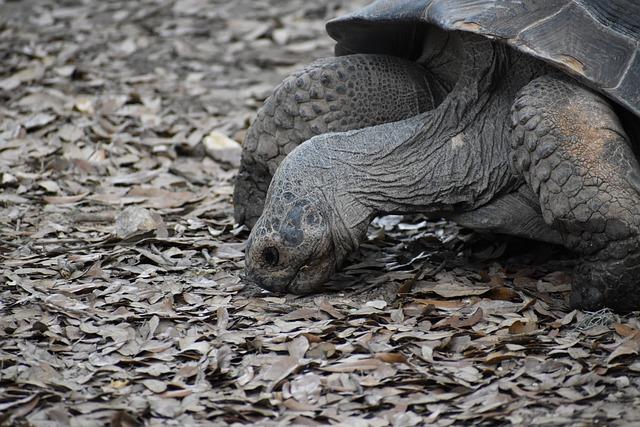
(270, 36, 503, 259)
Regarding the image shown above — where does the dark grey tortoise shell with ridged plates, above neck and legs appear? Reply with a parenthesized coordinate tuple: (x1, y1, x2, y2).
(327, 0, 640, 116)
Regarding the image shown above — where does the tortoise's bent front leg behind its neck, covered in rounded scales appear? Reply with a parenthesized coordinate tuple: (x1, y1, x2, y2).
(234, 55, 443, 227)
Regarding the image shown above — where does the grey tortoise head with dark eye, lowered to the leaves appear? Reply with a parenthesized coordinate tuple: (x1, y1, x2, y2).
(245, 184, 336, 294)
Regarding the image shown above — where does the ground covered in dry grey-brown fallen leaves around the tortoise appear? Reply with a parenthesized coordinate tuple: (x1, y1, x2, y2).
(0, 0, 640, 426)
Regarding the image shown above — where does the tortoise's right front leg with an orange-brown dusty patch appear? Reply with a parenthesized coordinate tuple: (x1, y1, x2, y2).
(512, 76, 640, 312)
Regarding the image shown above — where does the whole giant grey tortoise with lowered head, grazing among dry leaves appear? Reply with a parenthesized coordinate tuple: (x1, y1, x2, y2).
(234, 0, 640, 312)
